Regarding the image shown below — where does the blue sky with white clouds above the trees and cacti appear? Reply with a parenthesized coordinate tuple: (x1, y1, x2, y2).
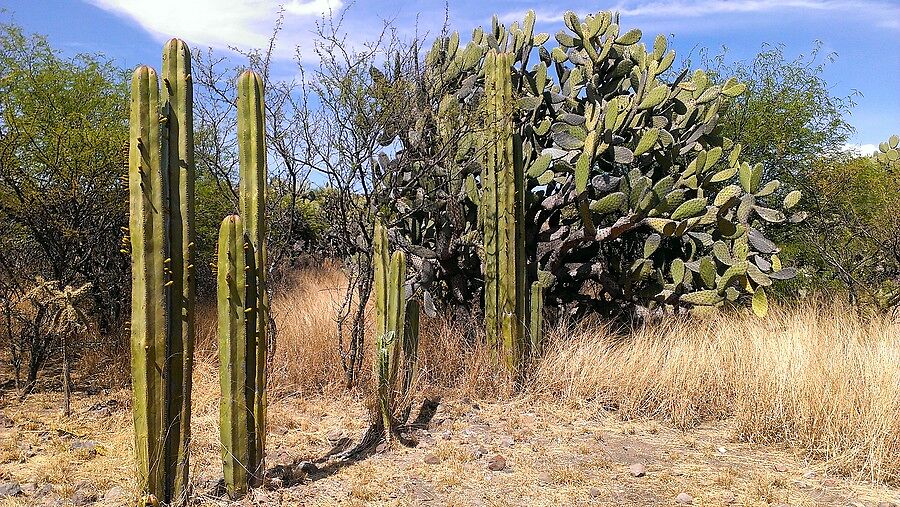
(0, 0, 900, 149)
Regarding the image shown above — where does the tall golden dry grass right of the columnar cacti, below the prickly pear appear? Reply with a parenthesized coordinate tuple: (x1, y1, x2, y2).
(532, 303, 900, 483)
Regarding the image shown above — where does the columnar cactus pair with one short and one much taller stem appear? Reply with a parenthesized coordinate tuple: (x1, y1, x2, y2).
(216, 70, 268, 498)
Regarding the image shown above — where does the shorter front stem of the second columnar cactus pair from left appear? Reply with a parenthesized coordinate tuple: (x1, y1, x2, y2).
(216, 215, 262, 498)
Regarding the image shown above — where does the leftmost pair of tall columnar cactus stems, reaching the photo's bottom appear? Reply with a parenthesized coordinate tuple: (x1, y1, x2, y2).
(128, 39, 195, 504)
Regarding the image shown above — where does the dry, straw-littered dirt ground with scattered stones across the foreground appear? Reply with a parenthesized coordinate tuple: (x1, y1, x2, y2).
(0, 390, 900, 507)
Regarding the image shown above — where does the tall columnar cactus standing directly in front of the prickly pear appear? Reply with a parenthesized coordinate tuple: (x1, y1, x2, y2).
(481, 50, 526, 370)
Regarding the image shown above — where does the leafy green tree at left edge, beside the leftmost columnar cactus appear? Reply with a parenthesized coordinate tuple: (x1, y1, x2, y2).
(0, 18, 129, 385)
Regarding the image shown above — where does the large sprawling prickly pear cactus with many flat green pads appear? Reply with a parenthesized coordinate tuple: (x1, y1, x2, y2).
(414, 12, 804, 320)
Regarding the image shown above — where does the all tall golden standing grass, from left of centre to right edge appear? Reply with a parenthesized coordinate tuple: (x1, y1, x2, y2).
(255, 271, 900, 483)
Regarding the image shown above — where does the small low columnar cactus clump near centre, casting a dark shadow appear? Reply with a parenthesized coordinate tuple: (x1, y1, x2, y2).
(373, 223, 419, 439)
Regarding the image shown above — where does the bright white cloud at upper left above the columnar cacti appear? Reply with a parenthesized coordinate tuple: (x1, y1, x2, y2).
(87, 0, 343, 58)
